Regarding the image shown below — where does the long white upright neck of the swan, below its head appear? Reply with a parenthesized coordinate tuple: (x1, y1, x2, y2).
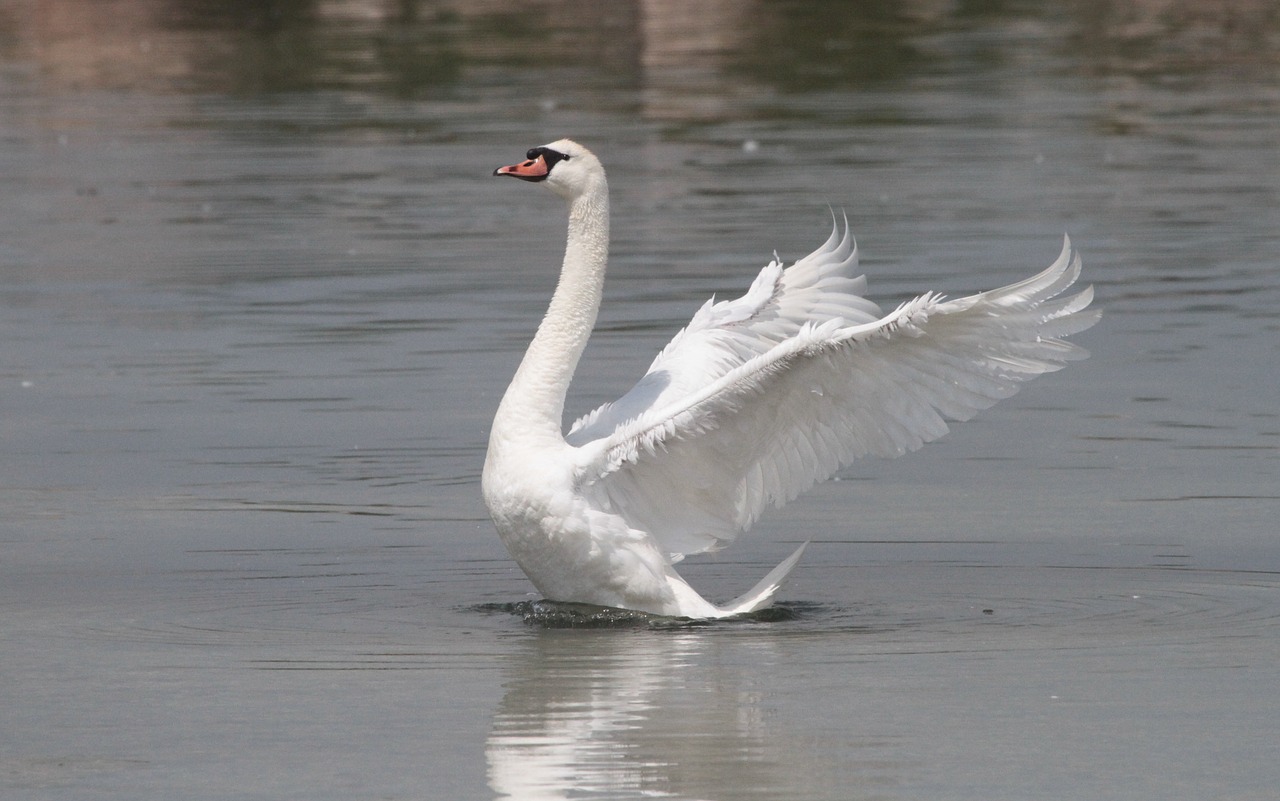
(490, 175, 609, 447)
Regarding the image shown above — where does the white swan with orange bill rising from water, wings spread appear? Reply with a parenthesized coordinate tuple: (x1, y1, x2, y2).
(481, 139, 1100, 619)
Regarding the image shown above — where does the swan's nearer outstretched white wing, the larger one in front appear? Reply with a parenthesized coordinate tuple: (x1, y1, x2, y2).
(571, 239, 1100, 558)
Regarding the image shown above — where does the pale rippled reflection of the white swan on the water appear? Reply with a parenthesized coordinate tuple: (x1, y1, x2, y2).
(485, 630, 778, 801)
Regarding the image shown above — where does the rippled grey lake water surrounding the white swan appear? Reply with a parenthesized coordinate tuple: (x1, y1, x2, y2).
(0, 0, 1280, 801)
